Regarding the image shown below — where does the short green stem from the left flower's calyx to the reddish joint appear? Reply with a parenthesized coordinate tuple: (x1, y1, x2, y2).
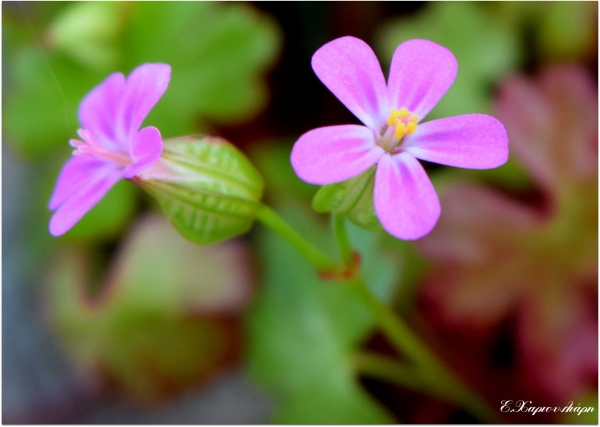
(257, 205, 335, 271)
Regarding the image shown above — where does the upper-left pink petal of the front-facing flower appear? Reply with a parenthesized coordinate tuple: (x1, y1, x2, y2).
(312, 37, 390, 132)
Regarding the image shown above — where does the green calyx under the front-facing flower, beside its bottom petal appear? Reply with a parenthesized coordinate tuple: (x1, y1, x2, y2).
(313, 166, 383, 231)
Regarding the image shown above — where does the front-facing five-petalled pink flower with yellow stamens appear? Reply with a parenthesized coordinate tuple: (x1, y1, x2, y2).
(291, 37, 508, 240)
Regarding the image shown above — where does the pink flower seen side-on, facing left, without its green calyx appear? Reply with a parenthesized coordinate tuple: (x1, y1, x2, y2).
(48, 64, 171, 236)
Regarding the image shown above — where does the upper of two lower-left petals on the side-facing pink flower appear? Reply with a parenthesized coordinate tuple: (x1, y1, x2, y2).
(48, 156, 114, 210)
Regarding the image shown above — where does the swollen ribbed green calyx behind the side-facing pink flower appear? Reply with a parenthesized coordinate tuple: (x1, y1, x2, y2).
(135, 136, 263, 244)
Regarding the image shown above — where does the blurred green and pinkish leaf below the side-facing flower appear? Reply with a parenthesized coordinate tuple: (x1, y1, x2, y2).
(47, 217, 251, 400)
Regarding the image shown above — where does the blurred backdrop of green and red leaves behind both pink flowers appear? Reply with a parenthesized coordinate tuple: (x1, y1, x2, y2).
(2, 2, 598, 424)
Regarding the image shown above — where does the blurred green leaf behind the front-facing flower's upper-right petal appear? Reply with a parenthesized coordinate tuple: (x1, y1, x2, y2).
(376, 2, 520, 120)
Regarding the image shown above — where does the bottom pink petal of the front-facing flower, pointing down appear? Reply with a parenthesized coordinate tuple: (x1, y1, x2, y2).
(375, 153, 440, 240)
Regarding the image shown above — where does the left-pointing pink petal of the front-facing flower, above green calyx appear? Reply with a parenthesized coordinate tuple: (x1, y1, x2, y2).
(291, 125, 385, 185)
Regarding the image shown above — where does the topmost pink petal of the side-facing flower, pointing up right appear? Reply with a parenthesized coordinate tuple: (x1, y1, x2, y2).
(117, 64, 171, 141)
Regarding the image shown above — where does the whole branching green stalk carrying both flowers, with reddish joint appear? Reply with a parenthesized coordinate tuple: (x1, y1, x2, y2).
(257, 205, 503, 423)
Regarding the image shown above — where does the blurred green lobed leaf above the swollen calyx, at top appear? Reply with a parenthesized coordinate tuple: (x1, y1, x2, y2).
(125, 2, 281, 136)
